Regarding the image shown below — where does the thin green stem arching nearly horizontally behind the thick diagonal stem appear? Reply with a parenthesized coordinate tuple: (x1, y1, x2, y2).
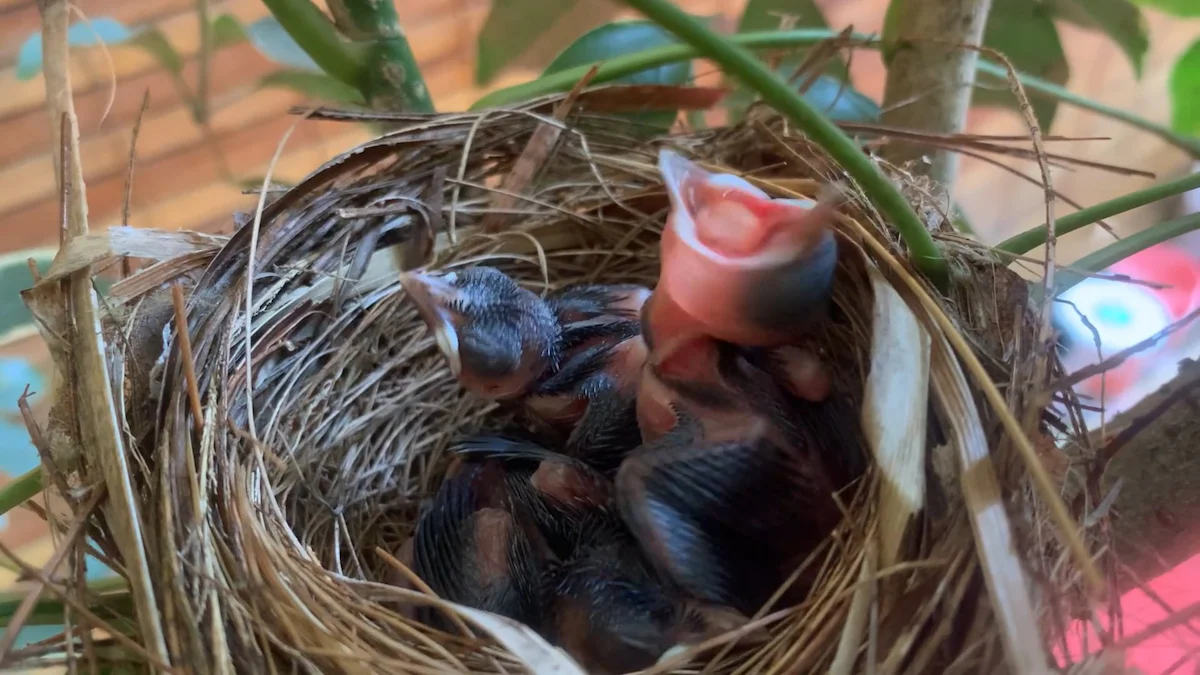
(470, 29, 1200, 159)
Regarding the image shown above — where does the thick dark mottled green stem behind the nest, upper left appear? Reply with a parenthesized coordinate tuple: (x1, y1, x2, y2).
(328, 0, 433, 113)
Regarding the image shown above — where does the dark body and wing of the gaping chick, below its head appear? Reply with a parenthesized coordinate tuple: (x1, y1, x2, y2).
(616, 321, 862, 615)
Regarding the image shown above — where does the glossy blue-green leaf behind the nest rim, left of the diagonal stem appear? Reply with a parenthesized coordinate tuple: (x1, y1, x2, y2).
(542, 20, 691, 130)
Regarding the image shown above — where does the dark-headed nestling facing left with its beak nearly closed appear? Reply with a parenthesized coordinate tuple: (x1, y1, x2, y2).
(401, 267, 650, 477)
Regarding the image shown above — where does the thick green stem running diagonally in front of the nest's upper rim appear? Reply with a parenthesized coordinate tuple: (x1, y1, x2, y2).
(624, 0, 949, 289)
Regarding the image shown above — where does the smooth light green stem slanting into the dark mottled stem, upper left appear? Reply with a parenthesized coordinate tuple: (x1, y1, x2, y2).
(255, 0, 367, 90)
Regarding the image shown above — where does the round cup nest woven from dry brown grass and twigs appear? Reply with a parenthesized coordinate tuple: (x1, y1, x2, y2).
(26, 96, 1103, 673)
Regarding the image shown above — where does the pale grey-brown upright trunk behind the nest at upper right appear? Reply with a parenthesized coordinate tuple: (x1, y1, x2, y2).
(883, 0, 991, 187)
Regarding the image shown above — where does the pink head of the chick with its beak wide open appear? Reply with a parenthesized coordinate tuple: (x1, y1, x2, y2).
(642, 149, 838, 401)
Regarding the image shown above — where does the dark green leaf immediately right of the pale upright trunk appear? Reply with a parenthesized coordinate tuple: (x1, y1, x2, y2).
(972, 0, 1070, 132)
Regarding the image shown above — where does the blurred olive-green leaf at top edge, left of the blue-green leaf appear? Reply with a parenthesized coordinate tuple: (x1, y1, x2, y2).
(475, 0, 578, 85)
